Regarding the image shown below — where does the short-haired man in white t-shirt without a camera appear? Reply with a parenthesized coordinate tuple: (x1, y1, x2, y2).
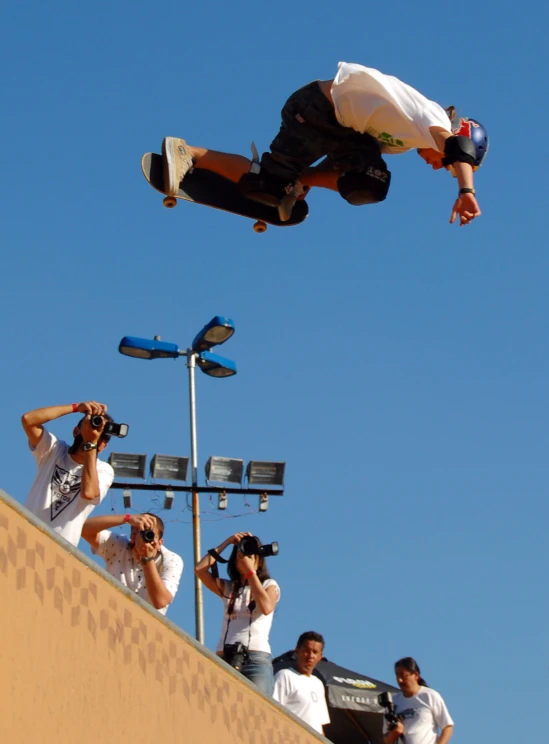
(273, 630, 330, 734)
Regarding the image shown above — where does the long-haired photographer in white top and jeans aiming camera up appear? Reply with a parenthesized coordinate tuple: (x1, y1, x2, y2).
(195, 532, 280, 696)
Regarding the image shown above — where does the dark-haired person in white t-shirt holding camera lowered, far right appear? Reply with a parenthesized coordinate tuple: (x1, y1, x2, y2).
(383, 656, 454, 744)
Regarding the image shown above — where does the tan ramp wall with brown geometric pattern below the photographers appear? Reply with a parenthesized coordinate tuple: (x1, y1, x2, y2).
(0, 491, 326, 744)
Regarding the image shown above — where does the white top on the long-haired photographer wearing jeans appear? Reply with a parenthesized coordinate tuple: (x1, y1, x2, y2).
(216, 579, 280, 654)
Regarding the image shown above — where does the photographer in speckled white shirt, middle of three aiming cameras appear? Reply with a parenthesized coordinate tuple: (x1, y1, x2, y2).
(82, 512, 183, 615)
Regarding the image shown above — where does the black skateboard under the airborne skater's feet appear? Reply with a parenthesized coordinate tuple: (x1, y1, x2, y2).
(141, 152, 309, 233)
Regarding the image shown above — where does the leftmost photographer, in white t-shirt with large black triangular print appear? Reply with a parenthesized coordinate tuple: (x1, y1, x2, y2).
(21, 400, 117, 547)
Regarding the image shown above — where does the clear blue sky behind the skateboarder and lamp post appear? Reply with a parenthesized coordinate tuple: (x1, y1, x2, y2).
(0, 0, 549, 744)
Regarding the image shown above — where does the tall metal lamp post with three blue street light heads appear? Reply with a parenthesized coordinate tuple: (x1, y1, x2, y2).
(118, 315, 236, 643)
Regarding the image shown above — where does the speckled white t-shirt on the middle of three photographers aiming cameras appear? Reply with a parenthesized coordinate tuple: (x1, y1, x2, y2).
(92, 530, 183, 615)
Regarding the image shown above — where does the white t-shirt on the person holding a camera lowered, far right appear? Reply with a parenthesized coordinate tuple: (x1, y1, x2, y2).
(383, 687, 454, 744)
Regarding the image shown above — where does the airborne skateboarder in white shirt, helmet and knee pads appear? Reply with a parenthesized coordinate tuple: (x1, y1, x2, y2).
(162, 62, 488, 225)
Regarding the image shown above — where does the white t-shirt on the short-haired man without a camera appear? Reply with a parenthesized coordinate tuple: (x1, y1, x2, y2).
(273, 669, 330, 734)
